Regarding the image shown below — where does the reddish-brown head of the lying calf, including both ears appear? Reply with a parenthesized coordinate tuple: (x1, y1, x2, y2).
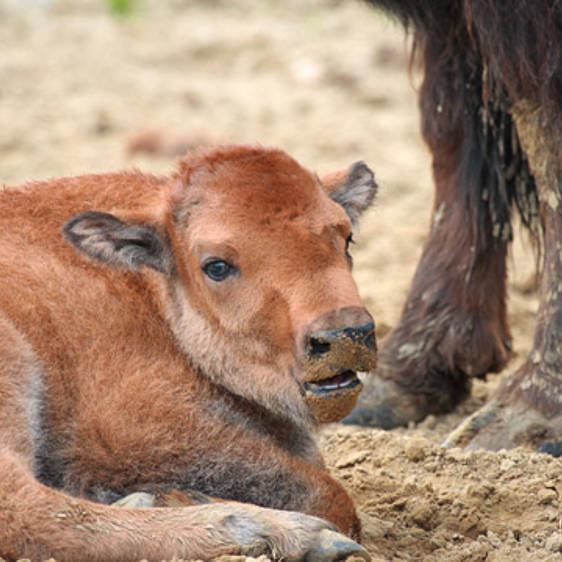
(65, 147, 376, 423)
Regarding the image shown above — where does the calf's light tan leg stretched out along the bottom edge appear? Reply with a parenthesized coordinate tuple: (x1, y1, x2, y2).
(0, 449, 369, 562)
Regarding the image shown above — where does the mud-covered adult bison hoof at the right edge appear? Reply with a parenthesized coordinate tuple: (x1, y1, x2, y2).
(443, 397, 562, 457)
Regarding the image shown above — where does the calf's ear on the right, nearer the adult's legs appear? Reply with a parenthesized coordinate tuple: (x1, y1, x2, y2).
(320, 162, 378, 224)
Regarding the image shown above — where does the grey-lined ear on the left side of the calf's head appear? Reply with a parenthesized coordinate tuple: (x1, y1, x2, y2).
(63, 211, 172, 273)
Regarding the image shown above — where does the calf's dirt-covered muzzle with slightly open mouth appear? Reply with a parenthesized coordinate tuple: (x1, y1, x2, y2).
(302, 307, 377, 422)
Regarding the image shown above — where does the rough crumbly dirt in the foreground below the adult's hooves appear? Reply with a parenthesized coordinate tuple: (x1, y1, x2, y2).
(322, 426, 562, 562)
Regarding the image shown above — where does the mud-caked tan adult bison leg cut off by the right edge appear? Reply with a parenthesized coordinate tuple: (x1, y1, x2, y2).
(445, 102, 562, 450)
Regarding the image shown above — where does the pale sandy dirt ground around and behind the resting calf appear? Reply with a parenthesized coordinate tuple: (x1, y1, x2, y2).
(0, 0, 562, 562)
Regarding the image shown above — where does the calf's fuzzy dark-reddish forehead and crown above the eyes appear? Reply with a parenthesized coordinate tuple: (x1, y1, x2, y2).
(177, 150, 349, 237)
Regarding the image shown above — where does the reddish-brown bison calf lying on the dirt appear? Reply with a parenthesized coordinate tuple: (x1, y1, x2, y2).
(0, 147, 376, 560)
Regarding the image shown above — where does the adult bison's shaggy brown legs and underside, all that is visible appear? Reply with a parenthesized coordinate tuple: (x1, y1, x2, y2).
(351, 0, 562, 448)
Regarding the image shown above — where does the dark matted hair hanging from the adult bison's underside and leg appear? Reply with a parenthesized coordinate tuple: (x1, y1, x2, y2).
(366, 0, 562, 250)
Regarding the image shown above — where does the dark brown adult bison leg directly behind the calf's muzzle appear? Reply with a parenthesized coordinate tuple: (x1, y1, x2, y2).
(346, 43, 521, 429)
